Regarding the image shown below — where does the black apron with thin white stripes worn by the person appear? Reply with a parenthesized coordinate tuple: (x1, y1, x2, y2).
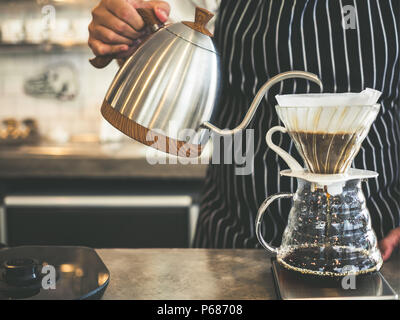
(194, 0, 400, 248)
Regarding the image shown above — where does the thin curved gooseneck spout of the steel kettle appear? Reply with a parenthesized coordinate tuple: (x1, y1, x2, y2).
(201, 71, 323, 135)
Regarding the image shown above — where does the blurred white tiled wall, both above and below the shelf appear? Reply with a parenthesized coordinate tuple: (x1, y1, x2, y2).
(0, 0, 122, 142)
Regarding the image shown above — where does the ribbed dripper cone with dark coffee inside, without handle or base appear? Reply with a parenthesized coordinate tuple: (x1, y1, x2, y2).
(276, 104, 380, 174)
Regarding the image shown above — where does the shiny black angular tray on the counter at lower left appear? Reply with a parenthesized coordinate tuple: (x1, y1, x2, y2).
(0, 246, 110, 300)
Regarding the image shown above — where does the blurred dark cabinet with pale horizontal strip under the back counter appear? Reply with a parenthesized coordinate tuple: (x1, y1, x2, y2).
(2, 179, 200, 248)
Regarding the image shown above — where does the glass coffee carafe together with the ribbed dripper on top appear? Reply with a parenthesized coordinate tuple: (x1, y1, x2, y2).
(256, 105, 382, 278)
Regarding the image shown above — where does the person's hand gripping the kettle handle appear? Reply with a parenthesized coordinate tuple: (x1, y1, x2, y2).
(88, 0, 170, 58)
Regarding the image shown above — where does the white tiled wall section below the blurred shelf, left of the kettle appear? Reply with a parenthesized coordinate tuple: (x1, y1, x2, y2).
(0, 47, 118, 142)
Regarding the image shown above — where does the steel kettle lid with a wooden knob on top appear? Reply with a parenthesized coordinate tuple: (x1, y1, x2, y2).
(165, 7, 217, 53)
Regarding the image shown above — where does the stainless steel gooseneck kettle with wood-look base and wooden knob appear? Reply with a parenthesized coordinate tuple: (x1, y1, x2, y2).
(92, 8, 322, 157)
